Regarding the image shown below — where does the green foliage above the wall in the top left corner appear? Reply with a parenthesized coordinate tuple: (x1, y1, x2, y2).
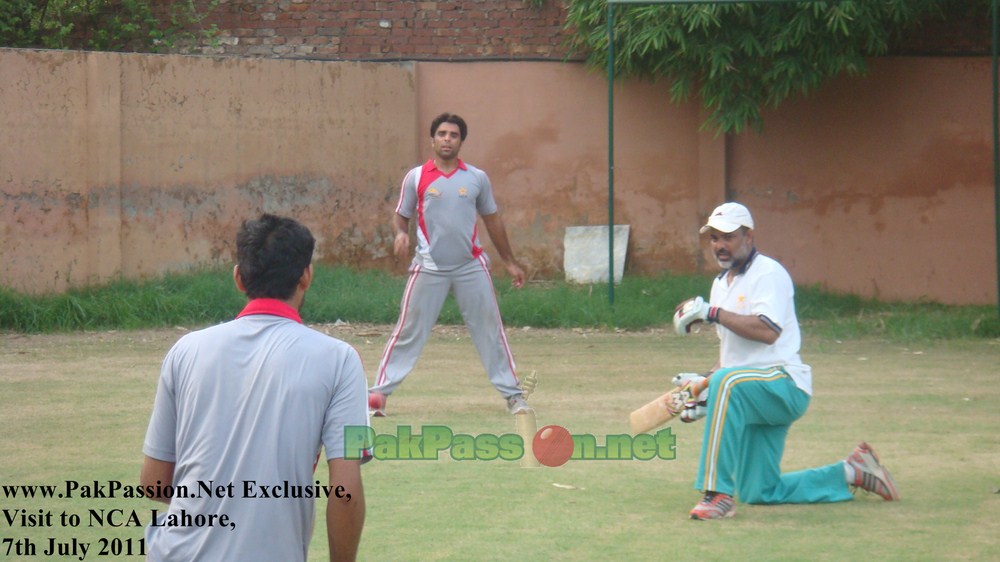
(0, 0, 217, 52)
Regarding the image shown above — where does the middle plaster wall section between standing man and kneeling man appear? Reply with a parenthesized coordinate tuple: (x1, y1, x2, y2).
(418, 62, 723, 276)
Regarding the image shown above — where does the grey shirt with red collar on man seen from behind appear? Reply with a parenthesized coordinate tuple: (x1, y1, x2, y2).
(143, 299, 368, 562)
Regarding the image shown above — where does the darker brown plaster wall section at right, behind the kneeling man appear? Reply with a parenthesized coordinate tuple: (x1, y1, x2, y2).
(730, 57, 997, 303)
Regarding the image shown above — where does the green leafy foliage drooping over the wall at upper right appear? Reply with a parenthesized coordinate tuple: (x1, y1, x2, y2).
(566, 0, 972, 133)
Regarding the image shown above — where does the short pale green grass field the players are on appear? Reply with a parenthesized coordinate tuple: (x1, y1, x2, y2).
(0, 325, 1000, 561)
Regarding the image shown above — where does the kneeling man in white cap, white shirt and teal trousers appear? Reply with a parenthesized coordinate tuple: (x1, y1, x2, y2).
(674, 203, 899, 519)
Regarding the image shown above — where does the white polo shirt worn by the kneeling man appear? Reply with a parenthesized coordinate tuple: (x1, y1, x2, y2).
(709, 249, 812, 395)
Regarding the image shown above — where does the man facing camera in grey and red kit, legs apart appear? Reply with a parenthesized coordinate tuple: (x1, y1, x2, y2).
(369, 113, 528, 416)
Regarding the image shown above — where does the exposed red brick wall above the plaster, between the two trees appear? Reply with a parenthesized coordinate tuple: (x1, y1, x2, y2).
(193, 0, 580, 60)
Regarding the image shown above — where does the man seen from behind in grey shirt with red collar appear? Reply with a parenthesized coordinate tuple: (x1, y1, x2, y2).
(140, 214, 368, 562)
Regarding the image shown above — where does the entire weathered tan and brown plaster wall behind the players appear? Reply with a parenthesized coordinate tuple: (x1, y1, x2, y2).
(0, 50, 996, 303)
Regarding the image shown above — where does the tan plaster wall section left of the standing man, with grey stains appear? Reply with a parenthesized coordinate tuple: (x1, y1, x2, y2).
(0, 50, 416, 291)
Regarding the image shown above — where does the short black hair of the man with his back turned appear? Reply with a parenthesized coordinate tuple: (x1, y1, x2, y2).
(236, 213, 316, 300)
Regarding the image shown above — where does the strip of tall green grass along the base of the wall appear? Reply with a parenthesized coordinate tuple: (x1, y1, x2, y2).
(0, 265, 1000, 340)
